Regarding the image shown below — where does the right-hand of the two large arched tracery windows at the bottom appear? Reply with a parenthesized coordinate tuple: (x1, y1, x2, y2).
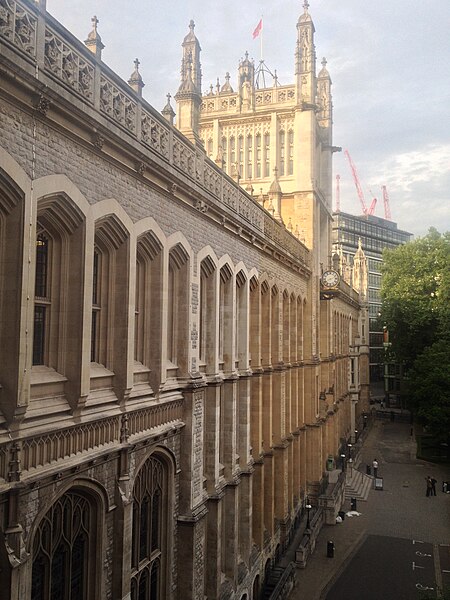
(131, 457, 167, 600)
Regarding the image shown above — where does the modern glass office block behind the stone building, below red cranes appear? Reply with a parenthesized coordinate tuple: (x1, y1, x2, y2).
(332, 212, 412, 393)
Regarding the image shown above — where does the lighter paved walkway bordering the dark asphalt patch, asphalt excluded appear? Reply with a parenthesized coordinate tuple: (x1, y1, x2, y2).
(289, 420, 450, 600)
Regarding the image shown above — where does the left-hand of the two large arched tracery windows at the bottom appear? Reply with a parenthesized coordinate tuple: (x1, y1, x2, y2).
(31, 490, 99, 600)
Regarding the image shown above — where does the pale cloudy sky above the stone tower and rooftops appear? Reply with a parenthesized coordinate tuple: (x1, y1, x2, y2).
(47, 0, 450, 236)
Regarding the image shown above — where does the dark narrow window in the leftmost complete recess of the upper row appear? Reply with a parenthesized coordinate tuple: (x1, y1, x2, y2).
(33, 233, 50, 365)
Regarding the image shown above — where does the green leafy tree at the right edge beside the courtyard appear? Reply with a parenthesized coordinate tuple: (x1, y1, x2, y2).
(381, 229, 450, 435)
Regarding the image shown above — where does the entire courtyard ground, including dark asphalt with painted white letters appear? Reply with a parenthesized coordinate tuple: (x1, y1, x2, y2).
(290, 421, 450, 600)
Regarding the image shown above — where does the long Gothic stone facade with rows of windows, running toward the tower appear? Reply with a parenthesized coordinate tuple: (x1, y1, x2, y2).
(0, 0, 368, 600)
